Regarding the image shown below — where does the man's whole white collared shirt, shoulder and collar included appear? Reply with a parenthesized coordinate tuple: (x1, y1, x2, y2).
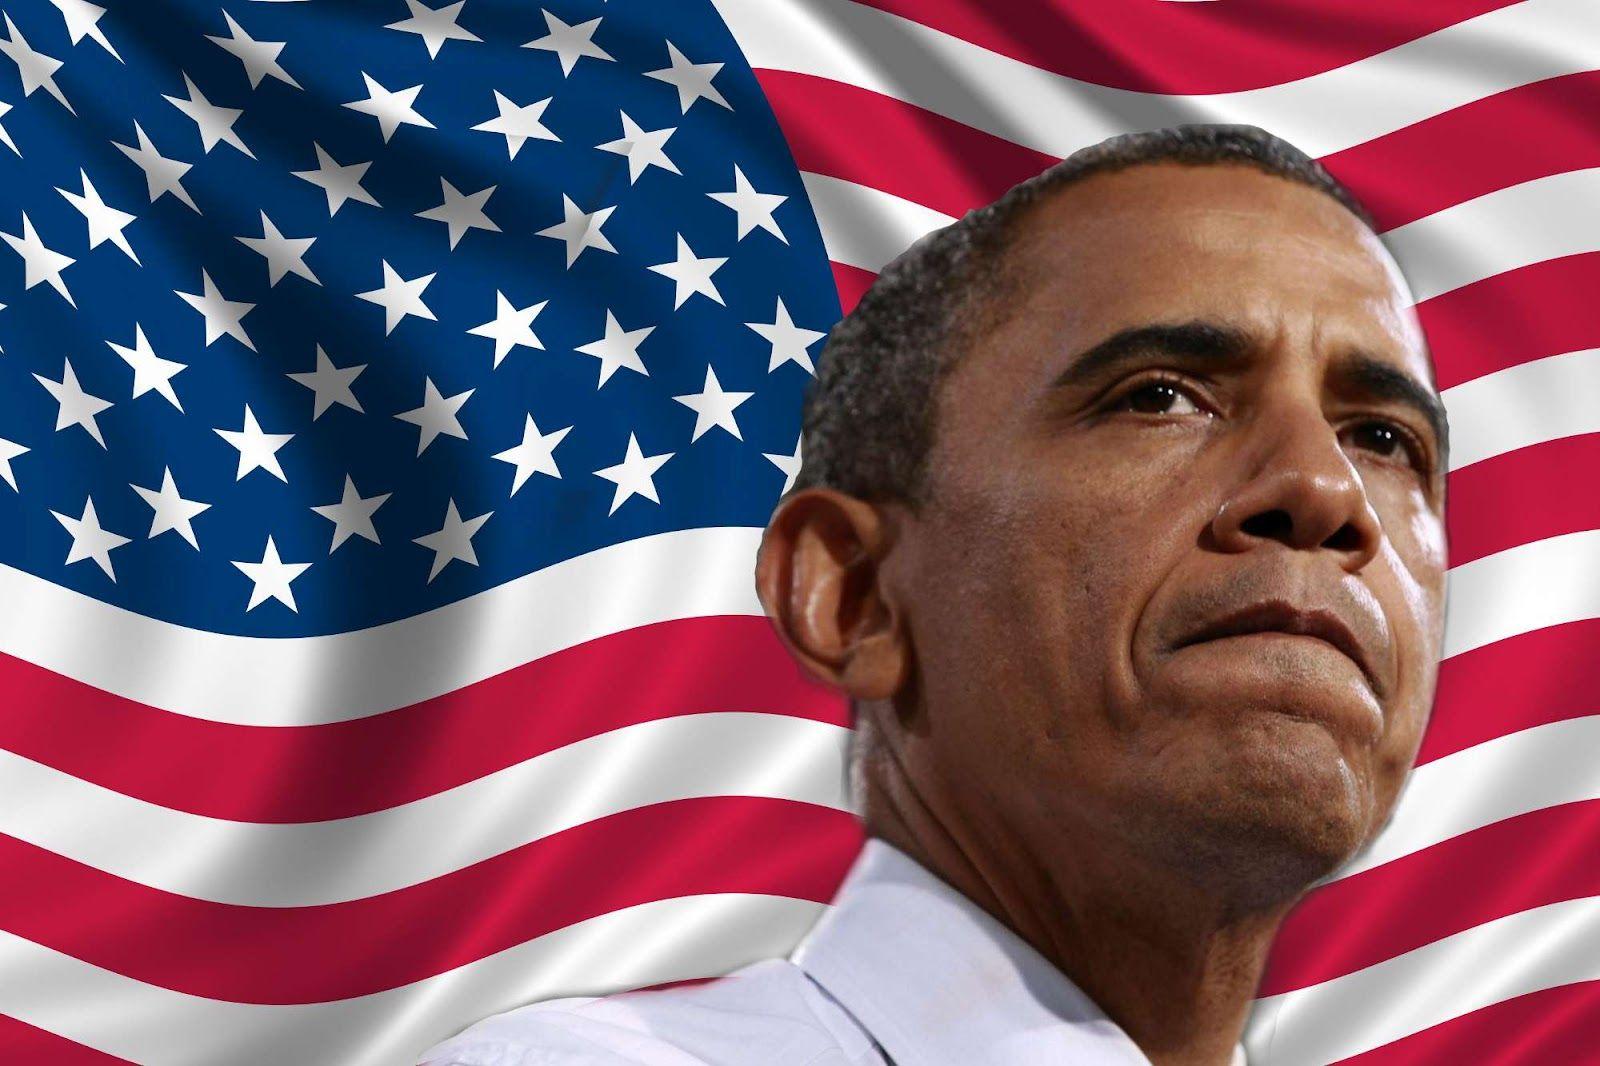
(422, 837, 1246, 1066)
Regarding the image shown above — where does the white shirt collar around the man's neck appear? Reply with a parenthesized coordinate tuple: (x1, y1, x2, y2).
(790, 837, 1248, 1066)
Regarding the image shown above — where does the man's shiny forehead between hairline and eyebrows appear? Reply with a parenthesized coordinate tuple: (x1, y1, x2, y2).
(995, 165, 1432, 378)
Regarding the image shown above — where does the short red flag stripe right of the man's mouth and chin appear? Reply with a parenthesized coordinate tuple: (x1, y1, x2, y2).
(1416, 619, 1600, 765)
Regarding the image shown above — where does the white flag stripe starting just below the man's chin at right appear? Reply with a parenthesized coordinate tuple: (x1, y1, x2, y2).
(1326, 707, 1600, 882)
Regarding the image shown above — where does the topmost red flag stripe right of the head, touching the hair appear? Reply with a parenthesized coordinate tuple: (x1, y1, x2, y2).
(1322, 70, 1600, 229)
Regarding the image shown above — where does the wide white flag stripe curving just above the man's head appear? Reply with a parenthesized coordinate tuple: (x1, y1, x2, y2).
(714, 0, 1600, 157)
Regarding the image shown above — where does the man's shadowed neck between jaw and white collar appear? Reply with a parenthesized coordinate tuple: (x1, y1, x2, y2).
(864, 758, 1294, 1066)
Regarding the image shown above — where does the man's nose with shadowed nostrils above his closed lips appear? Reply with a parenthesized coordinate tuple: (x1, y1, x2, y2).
(1211, 411, 1382, 573)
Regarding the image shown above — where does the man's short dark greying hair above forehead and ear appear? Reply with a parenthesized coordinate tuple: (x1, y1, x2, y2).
(790, 125, 1376, 509)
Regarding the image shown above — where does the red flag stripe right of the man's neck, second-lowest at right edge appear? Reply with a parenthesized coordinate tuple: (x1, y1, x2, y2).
(1258, 800, 1600, 996)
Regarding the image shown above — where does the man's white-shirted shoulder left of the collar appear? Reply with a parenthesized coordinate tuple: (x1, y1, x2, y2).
(422, 959, 883, 1066)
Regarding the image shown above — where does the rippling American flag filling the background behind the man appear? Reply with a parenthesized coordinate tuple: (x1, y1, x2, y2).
(0, 0, 1600, 1066)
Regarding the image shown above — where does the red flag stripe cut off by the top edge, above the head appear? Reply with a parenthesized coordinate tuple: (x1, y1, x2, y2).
(861, 0, 1512, 93)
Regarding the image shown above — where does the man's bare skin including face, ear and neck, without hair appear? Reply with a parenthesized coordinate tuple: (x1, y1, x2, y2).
(757, 163, 1446, 1066)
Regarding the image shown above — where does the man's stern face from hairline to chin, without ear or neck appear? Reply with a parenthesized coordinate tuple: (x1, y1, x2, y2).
(894, 165, 1445, 892)
